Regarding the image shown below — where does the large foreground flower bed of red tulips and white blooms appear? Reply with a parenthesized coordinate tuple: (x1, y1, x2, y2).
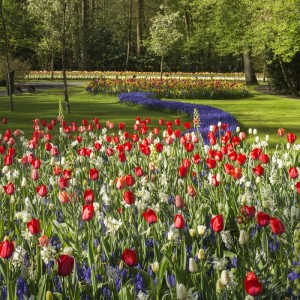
(0, 112, 300, 299)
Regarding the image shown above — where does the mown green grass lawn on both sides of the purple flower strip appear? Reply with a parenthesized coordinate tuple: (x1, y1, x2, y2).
(0, 82, 300, 146)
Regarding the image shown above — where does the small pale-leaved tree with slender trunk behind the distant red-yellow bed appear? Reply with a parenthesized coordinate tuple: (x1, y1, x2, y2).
(149, 9, 183, 79)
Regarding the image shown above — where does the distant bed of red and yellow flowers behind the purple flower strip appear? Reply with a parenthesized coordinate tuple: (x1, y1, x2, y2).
(86, 78, 250, 99)
